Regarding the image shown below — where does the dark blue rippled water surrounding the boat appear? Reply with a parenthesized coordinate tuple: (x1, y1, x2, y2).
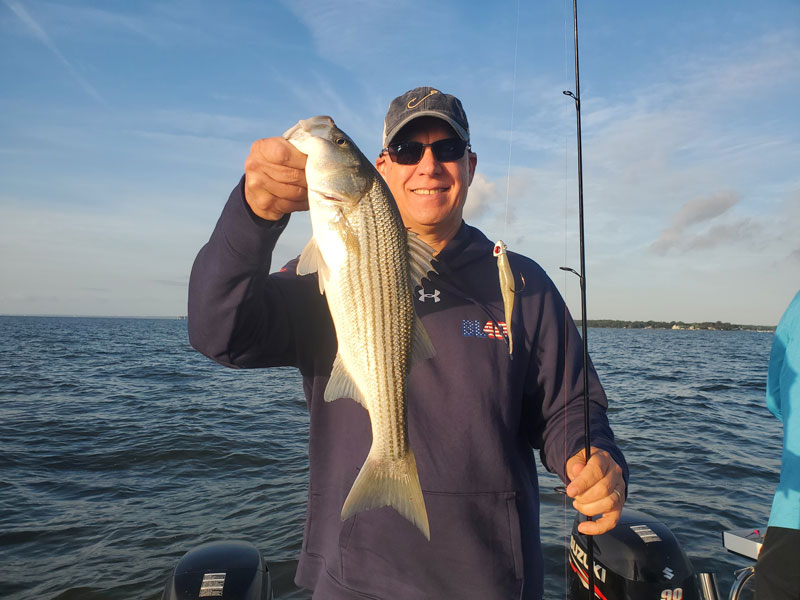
(0, 317, 780, 600)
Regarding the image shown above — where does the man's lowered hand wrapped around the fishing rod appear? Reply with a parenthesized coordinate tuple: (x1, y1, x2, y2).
(567, 446, 625, 535)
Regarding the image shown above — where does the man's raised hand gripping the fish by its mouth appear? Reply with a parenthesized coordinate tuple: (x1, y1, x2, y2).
(244, 137, 308, 221)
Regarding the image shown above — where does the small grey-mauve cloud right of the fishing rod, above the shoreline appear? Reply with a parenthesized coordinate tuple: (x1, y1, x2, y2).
(650, 192, 739, 255)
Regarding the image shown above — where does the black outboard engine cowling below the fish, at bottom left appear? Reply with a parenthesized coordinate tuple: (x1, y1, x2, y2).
(161, 541, 272, 600)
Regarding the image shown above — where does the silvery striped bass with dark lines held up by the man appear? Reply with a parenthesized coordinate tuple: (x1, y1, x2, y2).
(284, 116, 434, 540)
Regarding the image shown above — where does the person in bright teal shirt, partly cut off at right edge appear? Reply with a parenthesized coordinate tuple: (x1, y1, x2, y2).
(756, 292, 800, 600)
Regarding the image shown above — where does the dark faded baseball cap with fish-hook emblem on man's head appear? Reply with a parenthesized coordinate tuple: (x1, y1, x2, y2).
(383, 87, 469, 148)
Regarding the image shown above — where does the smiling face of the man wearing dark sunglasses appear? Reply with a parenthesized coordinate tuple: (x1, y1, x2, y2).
(375, 117, 478, 244)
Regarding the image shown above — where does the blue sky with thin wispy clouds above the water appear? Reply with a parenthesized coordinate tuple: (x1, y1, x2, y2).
(0, 0, 800, 325)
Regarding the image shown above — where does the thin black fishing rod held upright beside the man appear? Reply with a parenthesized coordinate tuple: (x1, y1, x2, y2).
(561, 0, 595, 600)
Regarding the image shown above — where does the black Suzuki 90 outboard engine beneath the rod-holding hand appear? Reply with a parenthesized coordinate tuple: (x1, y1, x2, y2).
(569, 508, 716, 600)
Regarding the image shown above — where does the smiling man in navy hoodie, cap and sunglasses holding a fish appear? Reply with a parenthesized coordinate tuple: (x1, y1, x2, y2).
(189, 87, 627, 600)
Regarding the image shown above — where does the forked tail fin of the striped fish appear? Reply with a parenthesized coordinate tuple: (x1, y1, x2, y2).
(342, 449, 431, 541)
